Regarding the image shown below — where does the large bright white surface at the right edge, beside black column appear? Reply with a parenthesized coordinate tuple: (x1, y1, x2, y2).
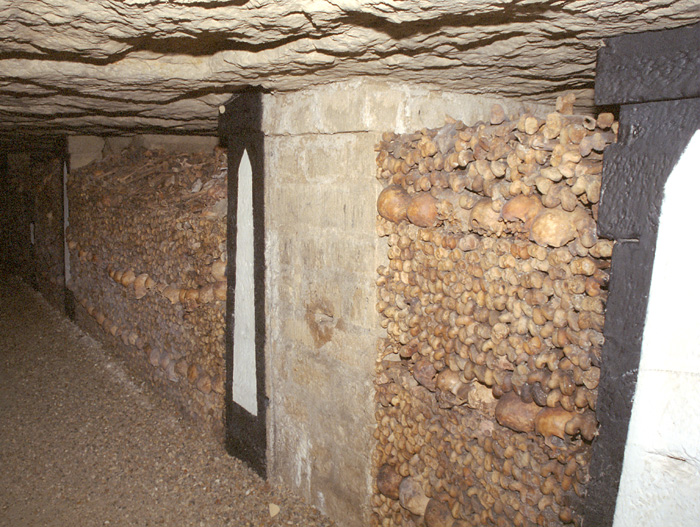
(614, 131, 700, 527)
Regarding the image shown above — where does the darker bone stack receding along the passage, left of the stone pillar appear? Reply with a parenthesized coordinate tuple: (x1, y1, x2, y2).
(68, 146, 226, 429)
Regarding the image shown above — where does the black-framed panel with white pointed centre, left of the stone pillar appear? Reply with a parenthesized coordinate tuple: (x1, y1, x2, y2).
(219, 92, 268, 477)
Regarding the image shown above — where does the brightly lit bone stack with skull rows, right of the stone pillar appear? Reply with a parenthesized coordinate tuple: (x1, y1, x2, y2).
(372, 96, 617, 527)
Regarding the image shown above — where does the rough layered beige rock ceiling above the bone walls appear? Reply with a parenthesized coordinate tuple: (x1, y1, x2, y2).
(0, 0, 700, 134)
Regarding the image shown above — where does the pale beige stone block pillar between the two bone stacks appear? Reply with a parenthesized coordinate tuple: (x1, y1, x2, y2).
(263, 82, 548, 526)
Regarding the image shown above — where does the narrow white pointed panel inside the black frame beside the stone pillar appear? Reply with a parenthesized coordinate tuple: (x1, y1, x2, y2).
(233, 148, 258, 415)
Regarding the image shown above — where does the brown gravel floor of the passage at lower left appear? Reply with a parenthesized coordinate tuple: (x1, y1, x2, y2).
(0, 277, 333, 527)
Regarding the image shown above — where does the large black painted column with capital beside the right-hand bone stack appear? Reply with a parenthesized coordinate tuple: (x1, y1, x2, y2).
(584, 24, 700, 527)
